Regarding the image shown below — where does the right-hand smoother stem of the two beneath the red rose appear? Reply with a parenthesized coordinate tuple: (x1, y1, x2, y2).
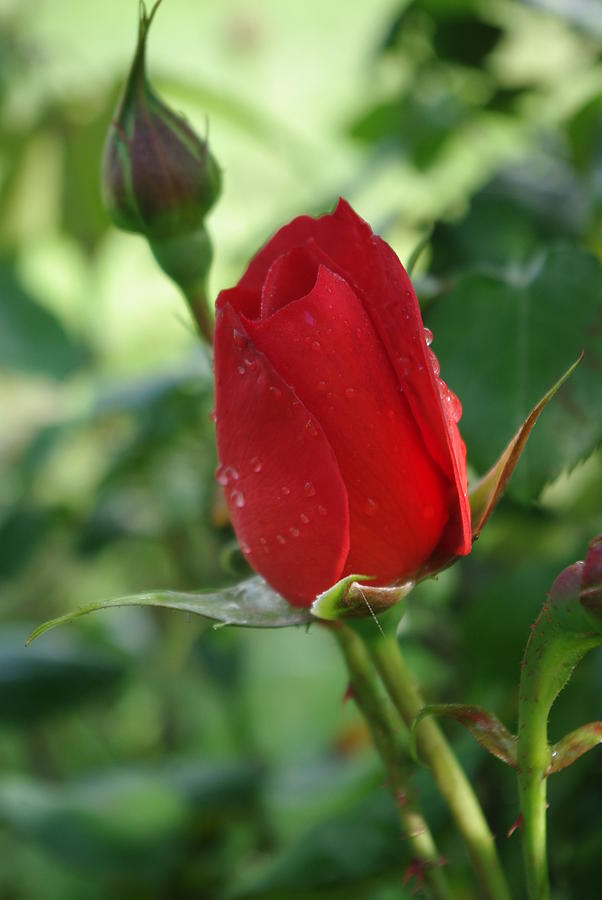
(368, 633, 510, 900)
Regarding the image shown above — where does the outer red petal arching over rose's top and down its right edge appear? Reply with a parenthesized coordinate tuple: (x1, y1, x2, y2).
(225, 199, 472, 558)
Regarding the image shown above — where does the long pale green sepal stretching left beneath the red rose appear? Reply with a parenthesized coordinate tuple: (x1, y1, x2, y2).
(27, 576, 312, 644)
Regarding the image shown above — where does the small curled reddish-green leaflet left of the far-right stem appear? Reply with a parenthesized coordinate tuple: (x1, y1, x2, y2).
(410, 703, 516, 768)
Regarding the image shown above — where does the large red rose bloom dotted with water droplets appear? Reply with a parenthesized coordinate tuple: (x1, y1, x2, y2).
(214, 200, 471, 606)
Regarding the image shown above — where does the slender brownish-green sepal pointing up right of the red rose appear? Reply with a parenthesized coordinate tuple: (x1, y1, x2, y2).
(468, 356, 583, 537)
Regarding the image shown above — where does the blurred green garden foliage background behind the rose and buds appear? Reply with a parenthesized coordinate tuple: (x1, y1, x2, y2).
(0, 0, 602, 900)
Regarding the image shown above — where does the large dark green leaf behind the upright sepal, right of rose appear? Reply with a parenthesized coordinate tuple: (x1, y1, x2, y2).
(427, 248, 602, 501)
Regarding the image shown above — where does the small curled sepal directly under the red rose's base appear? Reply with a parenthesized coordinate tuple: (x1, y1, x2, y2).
(311, 575, 414, 622)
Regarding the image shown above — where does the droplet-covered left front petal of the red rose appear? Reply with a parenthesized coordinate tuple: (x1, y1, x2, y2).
(215, 304, 349, 606)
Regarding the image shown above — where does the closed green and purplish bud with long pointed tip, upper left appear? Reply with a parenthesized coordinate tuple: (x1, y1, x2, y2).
(102, 0, 221, 342)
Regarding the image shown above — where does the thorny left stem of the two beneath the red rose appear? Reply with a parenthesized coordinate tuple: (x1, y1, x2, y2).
(331, 623, 450, 900)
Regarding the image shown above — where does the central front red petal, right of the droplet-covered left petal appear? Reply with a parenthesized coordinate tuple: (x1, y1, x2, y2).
(245, 257, 448, 584)
